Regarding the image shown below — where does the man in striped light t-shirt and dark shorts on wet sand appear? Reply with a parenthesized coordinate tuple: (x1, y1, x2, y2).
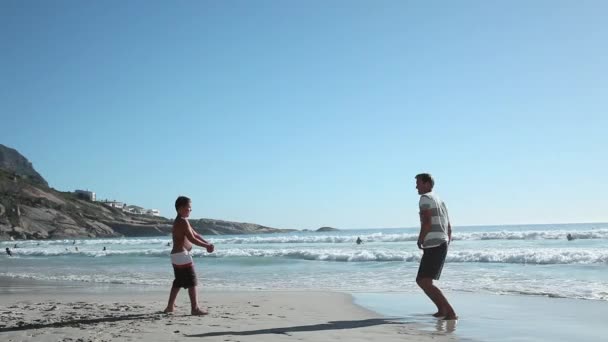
(416, 173, 458, 320)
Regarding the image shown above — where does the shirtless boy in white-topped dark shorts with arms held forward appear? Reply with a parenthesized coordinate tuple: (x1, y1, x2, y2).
(164, 196, 214, 315)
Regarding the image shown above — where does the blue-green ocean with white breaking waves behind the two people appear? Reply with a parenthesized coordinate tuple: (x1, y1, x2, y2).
(0, 224, 608, 301)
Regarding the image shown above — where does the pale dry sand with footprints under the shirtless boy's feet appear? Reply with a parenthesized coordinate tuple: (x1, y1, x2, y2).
(0, 286, 456, 342)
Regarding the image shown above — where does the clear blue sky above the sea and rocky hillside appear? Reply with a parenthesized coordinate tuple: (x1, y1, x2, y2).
(0, 0, 608, 229)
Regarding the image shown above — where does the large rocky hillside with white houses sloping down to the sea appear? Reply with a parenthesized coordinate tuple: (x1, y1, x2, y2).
(0, 144, 286, 240)
